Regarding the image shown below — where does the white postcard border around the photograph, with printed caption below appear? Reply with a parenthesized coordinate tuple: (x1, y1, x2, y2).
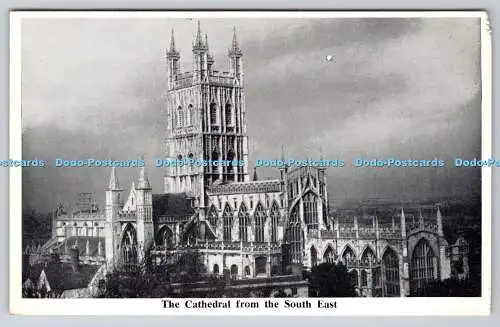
(9, 11, 492, 316)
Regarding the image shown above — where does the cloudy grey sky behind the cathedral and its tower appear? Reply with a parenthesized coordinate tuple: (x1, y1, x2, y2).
(21, 18, 481, 212)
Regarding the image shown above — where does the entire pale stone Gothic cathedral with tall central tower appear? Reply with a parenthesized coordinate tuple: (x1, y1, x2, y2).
(34, 25, 467, 296)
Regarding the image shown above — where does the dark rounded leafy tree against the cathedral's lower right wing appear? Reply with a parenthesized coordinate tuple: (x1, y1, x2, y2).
(307, 263, 357, 297)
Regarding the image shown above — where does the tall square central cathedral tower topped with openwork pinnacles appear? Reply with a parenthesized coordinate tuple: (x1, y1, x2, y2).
(165, 22, 249, 208)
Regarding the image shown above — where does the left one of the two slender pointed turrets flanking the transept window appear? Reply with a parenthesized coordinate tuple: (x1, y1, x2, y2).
(104, 167, 123, 269)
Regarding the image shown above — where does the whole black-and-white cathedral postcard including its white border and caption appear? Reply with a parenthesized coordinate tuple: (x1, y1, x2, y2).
(8, 11, 492, 315)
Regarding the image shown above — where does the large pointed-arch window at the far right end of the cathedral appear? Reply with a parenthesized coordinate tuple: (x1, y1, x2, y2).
(410, 238, 437, 292)
